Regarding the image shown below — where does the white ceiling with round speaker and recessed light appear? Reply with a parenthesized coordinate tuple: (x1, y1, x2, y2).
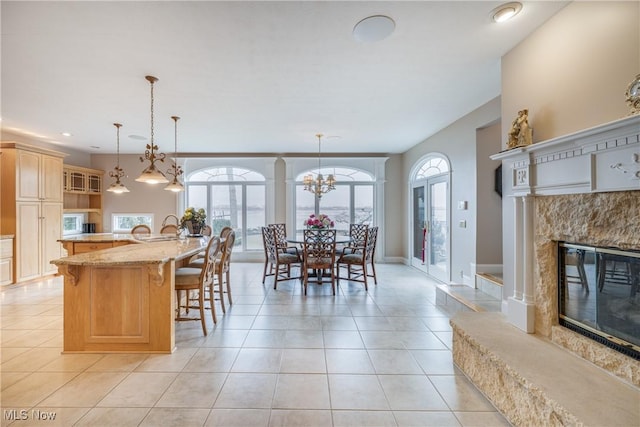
(1, 1, 567, 153)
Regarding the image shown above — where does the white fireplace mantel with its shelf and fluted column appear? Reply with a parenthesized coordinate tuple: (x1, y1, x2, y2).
(491, 115, 640, 335)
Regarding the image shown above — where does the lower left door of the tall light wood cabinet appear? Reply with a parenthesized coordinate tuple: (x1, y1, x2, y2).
(15, 202, 41, 281)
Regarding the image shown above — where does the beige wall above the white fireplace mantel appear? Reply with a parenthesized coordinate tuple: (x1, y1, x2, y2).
(502, 1, 640, 146)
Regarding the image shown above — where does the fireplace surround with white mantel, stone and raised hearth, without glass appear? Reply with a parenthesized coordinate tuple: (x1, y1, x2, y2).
(452, 115, 640, 424)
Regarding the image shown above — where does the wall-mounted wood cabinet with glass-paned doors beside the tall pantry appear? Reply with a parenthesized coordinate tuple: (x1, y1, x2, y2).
(63, 165, 104, 233)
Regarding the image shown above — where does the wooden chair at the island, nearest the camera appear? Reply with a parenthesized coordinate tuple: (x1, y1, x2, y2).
(175, 237, 222, 335)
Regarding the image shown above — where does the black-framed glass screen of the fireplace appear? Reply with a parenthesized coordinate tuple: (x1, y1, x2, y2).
(558, 243, 640, 358)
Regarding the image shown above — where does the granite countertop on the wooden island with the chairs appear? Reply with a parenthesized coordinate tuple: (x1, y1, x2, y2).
(51, 235, 208, 266)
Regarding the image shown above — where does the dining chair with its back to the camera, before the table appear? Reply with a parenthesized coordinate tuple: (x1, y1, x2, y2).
(302, 228, 336, 295)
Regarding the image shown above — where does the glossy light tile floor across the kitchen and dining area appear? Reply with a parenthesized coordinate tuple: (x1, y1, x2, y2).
(0, 263, 509, 427)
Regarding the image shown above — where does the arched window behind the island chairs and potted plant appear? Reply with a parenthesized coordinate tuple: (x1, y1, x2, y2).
(185, 166, 266, 251)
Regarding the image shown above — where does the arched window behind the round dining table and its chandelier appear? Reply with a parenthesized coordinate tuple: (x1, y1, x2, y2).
(295, 168, 374, 234)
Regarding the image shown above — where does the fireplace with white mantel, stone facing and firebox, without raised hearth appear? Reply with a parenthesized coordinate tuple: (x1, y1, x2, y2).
(491, 115, 640, 384)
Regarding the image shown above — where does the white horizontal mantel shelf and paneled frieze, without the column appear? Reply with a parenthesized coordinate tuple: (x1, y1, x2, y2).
(491, 115, 640, 196)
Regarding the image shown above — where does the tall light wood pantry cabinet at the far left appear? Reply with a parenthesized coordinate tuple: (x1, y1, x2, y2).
(0, 141, 66, 282)
